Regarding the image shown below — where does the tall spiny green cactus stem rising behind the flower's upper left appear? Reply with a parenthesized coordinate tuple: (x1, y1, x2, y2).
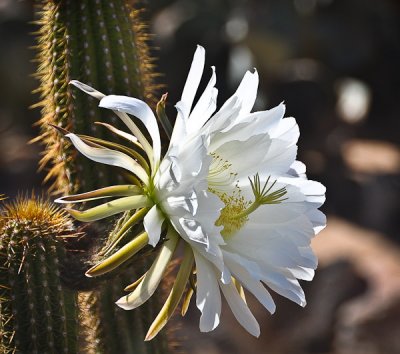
(35, 0, 156, 194)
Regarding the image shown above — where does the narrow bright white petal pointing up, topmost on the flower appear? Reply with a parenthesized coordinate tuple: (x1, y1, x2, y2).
(178, 45, 205, 119)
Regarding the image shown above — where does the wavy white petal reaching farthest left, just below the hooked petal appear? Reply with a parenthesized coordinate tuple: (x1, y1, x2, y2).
(65, 133, 148, 184)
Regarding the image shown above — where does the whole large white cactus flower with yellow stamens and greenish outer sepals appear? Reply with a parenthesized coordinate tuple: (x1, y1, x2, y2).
(57, 46, 326, 340)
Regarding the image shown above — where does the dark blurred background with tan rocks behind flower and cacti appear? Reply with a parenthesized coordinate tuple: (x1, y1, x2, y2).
(0, 0, 400, 354)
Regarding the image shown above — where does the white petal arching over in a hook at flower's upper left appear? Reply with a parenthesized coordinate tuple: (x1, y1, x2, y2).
(99, 95, 161, 168)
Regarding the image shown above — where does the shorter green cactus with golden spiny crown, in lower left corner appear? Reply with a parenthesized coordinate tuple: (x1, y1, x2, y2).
(0, 197, 78, 354)
